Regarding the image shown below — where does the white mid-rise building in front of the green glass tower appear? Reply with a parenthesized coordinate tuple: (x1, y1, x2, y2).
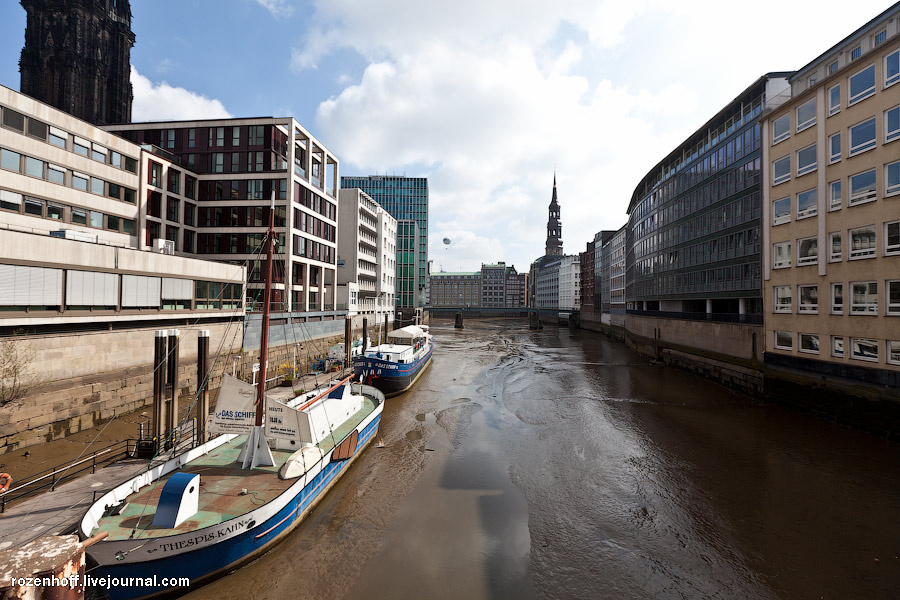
(337, 188, 397, 323)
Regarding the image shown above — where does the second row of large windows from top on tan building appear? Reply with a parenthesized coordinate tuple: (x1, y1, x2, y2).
(772, 106, 900, 186)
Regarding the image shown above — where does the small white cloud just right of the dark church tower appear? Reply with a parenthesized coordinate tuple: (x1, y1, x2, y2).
(131, 65, 232, 122)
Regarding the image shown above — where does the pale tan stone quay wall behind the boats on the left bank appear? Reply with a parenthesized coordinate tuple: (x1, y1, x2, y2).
(0, 318, 358, 455)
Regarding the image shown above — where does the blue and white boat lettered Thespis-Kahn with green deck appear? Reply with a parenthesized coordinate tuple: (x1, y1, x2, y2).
(79, 376, 384, 600)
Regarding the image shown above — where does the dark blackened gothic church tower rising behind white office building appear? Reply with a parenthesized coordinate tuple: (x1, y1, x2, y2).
(19, 0, 134, 125)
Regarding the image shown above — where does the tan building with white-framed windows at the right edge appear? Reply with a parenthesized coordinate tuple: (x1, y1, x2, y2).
(761, 4, 900, 372)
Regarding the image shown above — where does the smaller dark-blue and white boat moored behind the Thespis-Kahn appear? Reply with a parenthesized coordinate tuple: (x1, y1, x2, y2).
(353, 325, 434, 398)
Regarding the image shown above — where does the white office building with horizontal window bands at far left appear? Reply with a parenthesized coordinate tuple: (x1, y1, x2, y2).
(0, 87, 244, 334)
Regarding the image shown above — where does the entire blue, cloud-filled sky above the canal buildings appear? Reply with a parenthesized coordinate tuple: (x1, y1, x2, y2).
(0, 0, 891, 272)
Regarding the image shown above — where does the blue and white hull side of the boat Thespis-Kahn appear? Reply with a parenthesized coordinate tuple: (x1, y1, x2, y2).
(88, 412, 383, 600)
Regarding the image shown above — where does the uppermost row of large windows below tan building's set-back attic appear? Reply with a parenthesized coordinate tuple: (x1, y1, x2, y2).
(772, 50, 900, 146)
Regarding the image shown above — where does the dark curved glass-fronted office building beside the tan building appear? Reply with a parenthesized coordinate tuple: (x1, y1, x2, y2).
(625, 73, 789, 324)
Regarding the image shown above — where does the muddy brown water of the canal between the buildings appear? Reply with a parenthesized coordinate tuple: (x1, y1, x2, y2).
(186, 320, 900, 600)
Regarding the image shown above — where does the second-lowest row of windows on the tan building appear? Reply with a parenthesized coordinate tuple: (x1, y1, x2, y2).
(772, 280, 900, 316)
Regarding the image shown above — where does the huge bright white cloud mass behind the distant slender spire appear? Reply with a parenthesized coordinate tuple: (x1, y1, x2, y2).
(292, 0, 882, 270)
